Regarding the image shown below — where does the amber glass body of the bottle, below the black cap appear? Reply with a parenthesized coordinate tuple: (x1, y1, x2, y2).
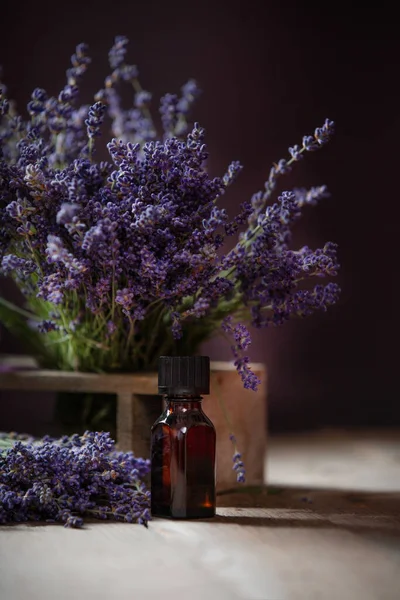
(151, 397, 216, 519)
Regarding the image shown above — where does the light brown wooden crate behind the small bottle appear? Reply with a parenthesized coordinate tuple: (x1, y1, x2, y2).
(0, 362, 267, 488)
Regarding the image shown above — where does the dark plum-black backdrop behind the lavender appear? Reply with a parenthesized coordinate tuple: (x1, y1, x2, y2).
(0, 0, 400, 430)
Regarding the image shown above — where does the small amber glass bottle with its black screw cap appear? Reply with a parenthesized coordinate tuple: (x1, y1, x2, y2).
(151, 356, 215, 519)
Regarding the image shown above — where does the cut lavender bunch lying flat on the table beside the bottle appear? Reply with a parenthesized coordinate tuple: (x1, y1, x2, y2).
(0, 431, 151, 527)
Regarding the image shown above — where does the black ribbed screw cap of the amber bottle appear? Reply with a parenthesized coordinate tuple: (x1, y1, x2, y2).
(158, 356, 210, 396)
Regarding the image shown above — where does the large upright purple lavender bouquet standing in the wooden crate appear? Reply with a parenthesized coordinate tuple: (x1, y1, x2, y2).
(0, 37, 339, 389)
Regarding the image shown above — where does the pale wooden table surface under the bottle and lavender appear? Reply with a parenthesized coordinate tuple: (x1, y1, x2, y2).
(0, 432, 400, 600)
